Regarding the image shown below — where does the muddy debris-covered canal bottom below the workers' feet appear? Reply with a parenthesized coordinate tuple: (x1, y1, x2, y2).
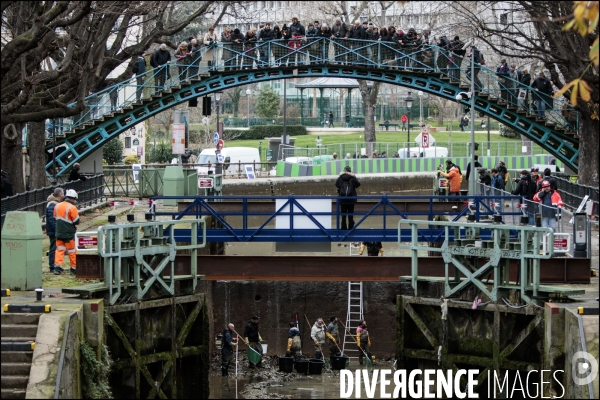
(209, 357, 391, 399)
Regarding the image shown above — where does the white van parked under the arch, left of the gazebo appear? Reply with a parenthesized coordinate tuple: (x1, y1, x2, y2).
(196, 147, 260, 175)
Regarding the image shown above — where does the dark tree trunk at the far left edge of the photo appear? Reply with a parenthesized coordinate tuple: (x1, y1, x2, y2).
(0, 124, 25, 194)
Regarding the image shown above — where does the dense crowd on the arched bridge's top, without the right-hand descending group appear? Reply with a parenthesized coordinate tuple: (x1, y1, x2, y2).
(138, 17, 482, 87)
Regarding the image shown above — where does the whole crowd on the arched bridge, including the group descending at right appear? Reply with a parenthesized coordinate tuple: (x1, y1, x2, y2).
(129, 17, 568, 120)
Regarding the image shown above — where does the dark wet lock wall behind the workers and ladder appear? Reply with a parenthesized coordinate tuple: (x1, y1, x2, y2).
(211, 280, 412, 359)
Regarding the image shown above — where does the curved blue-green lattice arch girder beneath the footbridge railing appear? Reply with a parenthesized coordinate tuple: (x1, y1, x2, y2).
(46, 38, 579, 176)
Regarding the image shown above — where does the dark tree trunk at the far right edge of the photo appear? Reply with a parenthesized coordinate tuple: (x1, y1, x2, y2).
(578, 109, 600, 187)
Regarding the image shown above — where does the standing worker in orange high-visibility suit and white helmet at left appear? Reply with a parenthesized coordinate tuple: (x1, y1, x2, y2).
(54, 189, 79, 275)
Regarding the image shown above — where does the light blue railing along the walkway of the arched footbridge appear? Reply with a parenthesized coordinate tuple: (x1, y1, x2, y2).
(47, 37, 578, 139)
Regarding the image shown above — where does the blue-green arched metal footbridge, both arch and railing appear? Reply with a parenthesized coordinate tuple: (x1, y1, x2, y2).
(46, 38, 579, 176)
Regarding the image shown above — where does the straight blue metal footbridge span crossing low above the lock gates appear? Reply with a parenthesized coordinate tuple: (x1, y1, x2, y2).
(151, 194, 523, 242)
